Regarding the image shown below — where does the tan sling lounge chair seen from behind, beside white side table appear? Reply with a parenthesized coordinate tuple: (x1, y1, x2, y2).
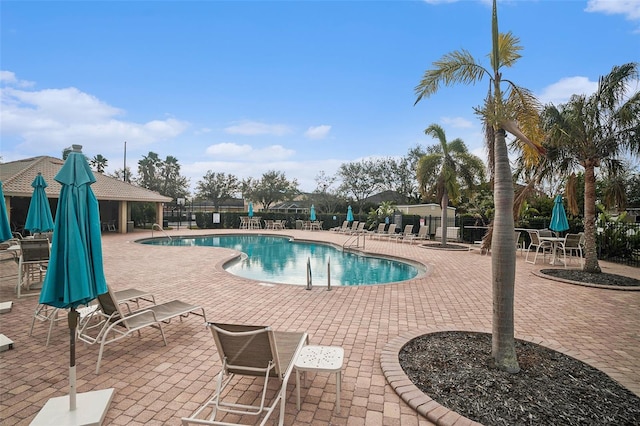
(182, 323, 309, 426)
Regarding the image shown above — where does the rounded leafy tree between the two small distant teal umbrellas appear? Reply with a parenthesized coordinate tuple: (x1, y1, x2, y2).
(241, 170, 300, 210)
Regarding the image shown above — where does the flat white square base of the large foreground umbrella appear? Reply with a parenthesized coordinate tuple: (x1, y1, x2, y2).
(31, 388, 114, 426)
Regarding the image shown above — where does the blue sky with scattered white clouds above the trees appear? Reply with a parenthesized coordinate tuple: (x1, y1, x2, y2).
(0, 0, 640, 191)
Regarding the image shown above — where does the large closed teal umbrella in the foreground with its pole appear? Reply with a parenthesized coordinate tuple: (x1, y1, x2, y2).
(34, 145, 113, 416)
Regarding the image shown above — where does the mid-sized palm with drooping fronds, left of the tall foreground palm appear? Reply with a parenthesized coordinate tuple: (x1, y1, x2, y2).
(417, 124, 484, 246)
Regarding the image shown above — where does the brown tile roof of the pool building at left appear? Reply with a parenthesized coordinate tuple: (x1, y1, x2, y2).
(0, 156, 172, 203)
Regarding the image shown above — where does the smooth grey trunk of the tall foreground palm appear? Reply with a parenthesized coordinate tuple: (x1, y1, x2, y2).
(491, 129, 520, 373)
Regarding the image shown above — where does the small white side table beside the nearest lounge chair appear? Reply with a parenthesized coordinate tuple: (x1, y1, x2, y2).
(294, 345, 344, 413)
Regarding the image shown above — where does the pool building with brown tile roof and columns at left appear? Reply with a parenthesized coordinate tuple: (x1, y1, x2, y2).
(0, 156, 172, 233)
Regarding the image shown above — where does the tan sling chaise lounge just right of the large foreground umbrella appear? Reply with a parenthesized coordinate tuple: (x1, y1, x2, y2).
(78, 288, 207, 374)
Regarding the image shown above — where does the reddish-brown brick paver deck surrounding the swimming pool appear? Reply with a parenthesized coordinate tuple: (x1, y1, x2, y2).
(0, 229, 640, 425)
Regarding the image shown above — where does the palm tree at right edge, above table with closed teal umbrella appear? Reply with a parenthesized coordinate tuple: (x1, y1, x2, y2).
(543, 63, 640, 273)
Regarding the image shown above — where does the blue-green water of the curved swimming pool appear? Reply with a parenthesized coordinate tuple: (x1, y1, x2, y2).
(142, 235, 419, 286)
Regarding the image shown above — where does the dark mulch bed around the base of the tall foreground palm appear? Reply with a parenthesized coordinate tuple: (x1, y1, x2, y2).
(399, 332, 640, 425)
